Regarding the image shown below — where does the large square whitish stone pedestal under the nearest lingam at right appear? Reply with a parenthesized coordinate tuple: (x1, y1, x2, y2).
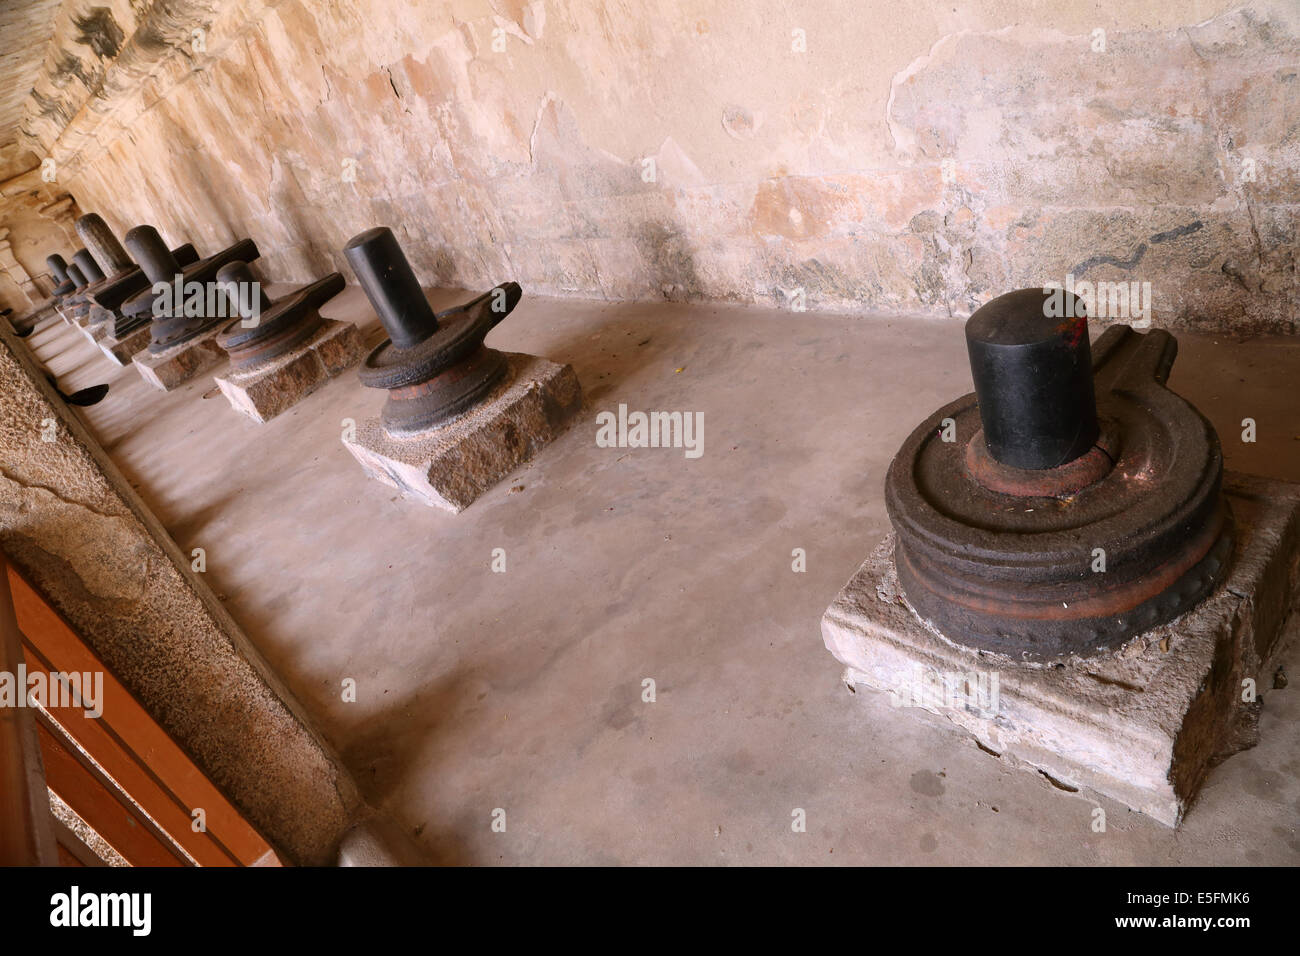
(822, 472, 1300, 826)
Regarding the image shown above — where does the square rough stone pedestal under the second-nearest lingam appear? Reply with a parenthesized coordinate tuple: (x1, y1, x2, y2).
(343, 352, 582, 511)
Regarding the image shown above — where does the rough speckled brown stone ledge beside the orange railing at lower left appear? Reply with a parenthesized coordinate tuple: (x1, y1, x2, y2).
(0, 328, 360, 865)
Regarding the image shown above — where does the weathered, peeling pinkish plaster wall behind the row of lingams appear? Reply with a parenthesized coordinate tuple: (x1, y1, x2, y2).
(12, 0, 1300, 330)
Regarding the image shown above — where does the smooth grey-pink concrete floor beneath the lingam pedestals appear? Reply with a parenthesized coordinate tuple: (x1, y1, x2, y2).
(29, 287, 1300, 865)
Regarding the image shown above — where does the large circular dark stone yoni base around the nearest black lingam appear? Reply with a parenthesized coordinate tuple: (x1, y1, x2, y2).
(885, 326, 1232, 661)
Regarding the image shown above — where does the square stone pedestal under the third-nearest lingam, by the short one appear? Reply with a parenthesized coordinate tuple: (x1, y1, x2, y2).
(217, 319, 365, 423)
